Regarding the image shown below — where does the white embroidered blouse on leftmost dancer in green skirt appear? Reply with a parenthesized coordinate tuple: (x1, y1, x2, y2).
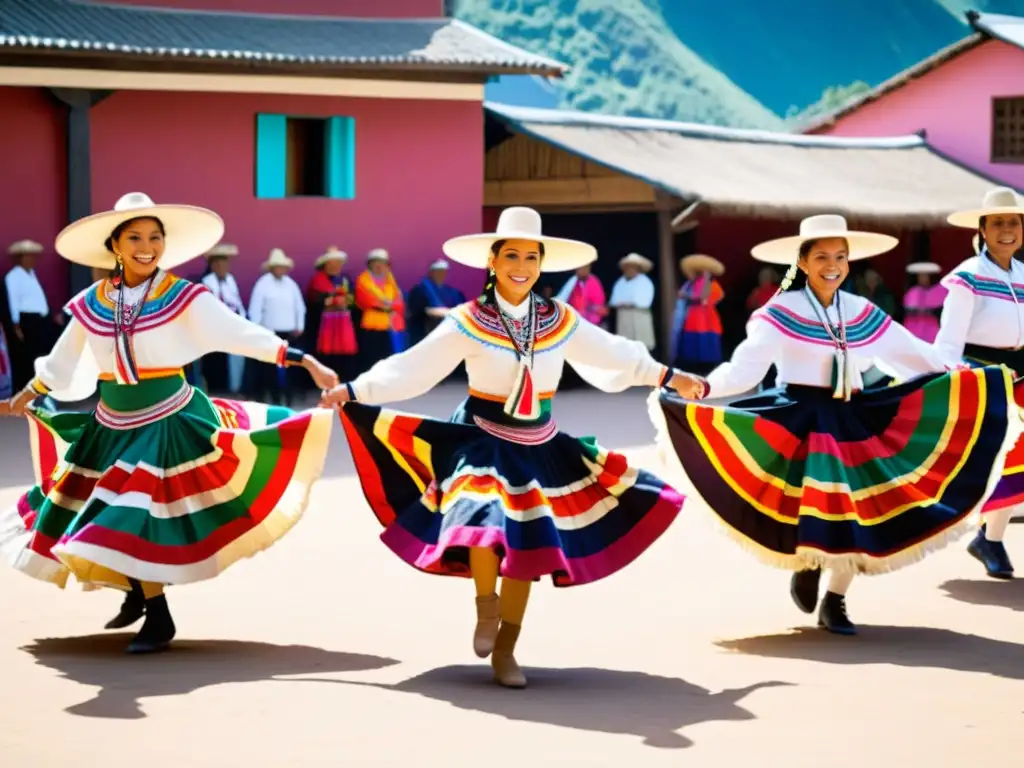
(31, 271, 288, 400)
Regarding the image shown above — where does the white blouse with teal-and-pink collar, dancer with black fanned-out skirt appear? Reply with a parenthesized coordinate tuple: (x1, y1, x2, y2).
(707, 291, 947, 397)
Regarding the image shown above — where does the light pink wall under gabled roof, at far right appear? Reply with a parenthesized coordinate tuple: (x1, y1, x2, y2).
(811, 40, 1024, 190)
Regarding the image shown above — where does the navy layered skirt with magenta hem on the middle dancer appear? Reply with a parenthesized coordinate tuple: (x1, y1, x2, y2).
(341, 396, 683, 587)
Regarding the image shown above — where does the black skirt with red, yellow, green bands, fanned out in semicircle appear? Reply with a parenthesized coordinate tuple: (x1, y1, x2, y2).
(650, 367, 1021, 573)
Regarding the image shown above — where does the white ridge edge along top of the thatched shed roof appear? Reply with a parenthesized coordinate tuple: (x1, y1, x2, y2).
(483, 101, 927, 150)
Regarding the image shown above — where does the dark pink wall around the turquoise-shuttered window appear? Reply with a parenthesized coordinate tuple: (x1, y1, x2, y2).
(88, 91, 483, 298)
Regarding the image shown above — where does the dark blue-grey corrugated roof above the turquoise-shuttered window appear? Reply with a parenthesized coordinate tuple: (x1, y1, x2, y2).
(0, 0, 567, 76)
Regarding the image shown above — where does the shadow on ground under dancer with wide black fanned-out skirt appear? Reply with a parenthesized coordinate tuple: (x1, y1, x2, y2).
(716, 625, 1024, 680)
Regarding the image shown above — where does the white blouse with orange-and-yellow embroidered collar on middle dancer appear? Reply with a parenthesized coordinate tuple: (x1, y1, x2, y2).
(351, 296, 669, 404)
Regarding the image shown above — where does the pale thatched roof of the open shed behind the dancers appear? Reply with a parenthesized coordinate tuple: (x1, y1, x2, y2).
(485, 102, 1015, 227)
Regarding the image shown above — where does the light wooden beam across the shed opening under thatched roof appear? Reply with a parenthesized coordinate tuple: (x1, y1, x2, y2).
(483, 176, 654, 208)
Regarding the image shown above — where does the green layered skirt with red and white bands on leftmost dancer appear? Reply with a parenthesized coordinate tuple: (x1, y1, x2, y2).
(0, 376, 334, 589)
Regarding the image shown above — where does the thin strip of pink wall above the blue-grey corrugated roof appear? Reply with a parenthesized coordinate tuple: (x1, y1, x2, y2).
(94, 0, 443, 18)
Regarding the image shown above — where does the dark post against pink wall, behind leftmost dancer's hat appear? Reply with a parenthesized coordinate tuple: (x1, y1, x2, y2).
(49, 88, 114, 296)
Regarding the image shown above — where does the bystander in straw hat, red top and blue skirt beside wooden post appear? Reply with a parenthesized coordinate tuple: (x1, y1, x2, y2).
(672, 253, 725, 373)
